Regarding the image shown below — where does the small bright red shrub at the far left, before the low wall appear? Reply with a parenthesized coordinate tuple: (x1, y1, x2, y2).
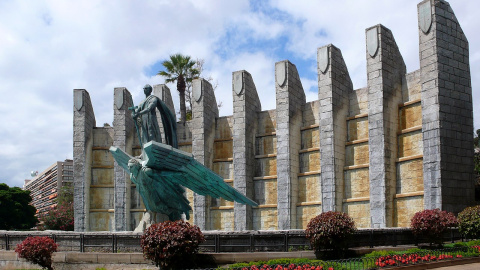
(15, 236, 57, 269)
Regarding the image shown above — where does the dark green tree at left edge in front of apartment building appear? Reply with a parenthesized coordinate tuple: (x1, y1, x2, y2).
(0, 183, 38, 230)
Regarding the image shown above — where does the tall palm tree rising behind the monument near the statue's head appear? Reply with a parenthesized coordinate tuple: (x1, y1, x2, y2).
(157, 53, 199, 122)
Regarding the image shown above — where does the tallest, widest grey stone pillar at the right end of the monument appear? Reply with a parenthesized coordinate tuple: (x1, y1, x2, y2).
(418, 0, 474, 212)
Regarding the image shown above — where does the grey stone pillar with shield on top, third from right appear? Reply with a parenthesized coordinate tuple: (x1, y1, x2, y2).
(317, 44, 353, 212)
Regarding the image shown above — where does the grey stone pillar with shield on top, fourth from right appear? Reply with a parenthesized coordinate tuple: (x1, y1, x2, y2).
(275, 60, 306, 230)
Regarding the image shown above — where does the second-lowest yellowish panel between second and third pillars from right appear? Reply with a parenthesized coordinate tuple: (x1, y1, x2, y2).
(344, 168, 370, 199)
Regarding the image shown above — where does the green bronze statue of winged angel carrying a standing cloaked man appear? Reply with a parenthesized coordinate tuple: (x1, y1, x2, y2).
(110, 84, 257, 230)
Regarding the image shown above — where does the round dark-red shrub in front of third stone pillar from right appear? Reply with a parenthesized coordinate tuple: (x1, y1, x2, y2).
(305, 211, 356, 258)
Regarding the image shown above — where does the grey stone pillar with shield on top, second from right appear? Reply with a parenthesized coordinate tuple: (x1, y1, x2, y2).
(366, 25, 406, 228)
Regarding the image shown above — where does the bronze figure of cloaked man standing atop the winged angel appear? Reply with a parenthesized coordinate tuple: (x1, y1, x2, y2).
(132, 84, 178, 148)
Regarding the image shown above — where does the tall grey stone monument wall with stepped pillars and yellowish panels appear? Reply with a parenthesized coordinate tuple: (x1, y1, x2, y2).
(74, 0, 474, 231)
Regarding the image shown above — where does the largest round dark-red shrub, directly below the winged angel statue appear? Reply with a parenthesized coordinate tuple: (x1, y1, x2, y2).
(141, 220, 205, 269)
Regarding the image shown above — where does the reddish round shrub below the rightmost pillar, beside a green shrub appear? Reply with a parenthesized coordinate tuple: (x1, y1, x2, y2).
(410, 209, 458, 246)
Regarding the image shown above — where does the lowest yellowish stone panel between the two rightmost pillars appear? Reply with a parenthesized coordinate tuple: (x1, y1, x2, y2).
(393, 196, 424, 227)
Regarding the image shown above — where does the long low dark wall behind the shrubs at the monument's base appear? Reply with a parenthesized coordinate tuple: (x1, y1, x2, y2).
(0, 229, 463, 253)
